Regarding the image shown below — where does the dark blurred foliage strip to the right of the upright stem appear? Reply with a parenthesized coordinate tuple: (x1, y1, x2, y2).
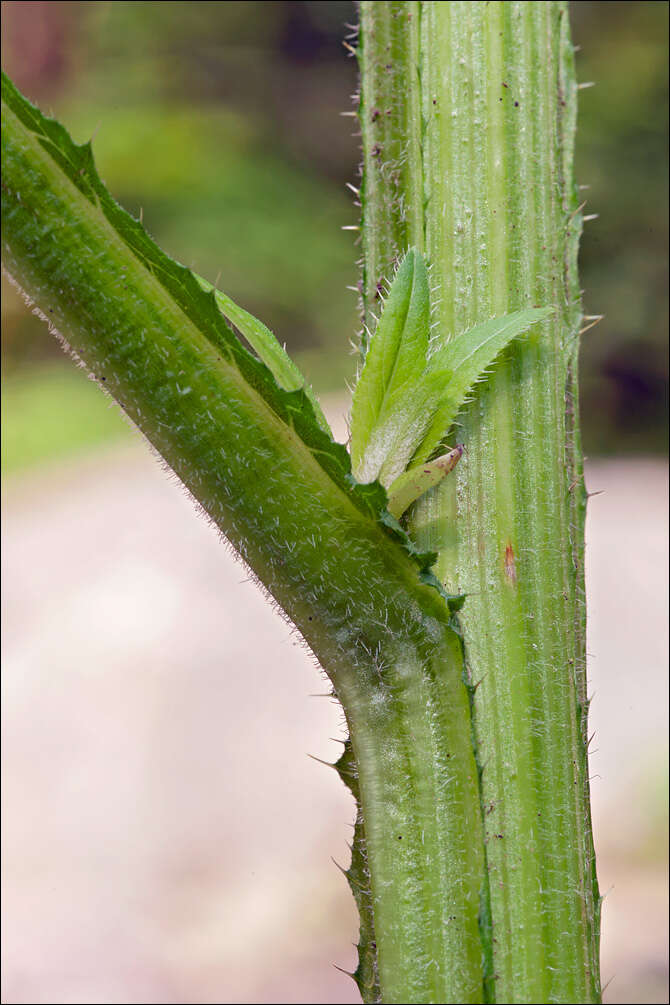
(571, 3, 668, 453)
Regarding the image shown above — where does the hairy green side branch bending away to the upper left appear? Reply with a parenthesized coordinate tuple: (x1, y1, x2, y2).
(2, 79, 483, 1002)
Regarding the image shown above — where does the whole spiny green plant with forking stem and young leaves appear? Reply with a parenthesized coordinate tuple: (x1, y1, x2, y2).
(2, 0, 600, 1003)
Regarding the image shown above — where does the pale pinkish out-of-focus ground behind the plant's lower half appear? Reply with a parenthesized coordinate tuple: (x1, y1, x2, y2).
(2, 395, 667, 1005)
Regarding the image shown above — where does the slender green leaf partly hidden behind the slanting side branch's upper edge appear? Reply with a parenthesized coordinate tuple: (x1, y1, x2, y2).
(193, 272, 330, 435)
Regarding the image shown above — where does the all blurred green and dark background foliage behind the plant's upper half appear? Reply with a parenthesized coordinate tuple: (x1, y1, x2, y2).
(2, 0, 668, 472)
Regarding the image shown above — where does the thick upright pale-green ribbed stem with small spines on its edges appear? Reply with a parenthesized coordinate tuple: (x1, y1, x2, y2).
(360, 0, 600, 1002)
